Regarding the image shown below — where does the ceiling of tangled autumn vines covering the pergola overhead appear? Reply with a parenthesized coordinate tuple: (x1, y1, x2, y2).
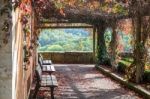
(34, 0, 150, 23)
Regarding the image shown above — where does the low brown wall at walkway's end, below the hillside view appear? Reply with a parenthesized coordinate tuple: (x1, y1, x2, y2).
(39, 52, 94, 64)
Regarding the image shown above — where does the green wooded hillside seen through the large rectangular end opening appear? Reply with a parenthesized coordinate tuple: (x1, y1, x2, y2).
(38, 29, 93, 51)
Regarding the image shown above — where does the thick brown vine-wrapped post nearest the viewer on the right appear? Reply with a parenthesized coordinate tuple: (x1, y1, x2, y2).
(126, 0, 150, 83)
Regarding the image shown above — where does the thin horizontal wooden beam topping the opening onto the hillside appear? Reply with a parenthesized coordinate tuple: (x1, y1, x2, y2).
(37, 26, 93, 29)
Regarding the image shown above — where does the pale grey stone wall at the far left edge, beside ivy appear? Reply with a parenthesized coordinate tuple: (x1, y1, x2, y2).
(0, 0, 12, 99)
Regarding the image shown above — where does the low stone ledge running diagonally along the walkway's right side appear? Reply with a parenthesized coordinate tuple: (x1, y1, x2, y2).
(95, 66, 150, 99)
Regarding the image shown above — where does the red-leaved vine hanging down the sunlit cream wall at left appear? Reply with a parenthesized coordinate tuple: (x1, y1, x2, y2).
(19, 0, 32, 70)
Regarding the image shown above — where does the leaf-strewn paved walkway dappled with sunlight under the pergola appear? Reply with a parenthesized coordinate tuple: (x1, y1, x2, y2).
(37, 64, 141, 99)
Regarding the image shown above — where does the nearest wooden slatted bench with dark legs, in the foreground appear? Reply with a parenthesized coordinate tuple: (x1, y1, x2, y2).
(33, 66, 58, 99)
